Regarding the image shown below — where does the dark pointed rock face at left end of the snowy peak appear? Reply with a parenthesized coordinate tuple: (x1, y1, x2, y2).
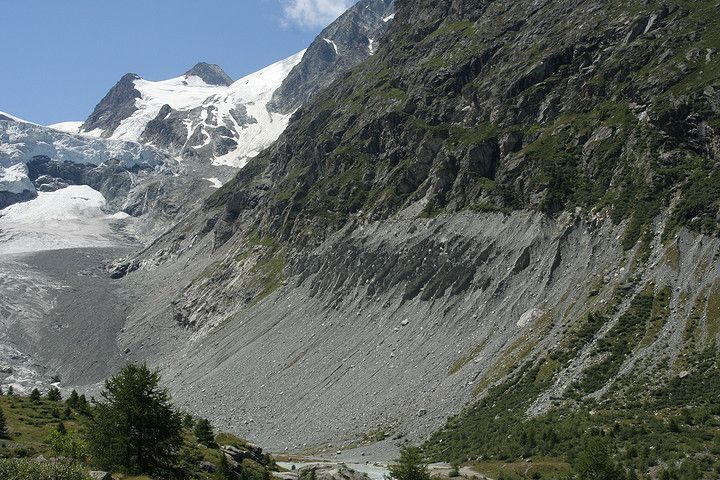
(80, 73, 140, 138)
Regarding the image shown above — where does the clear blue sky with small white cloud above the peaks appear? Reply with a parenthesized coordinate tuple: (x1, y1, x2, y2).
(0, 0, 354, 124)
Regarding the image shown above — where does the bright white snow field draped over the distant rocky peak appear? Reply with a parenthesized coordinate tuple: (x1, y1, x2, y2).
(87, 50, 305, 167)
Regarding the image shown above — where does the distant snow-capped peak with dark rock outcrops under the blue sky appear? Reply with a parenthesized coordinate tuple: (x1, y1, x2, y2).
(81, 51, 304, 167)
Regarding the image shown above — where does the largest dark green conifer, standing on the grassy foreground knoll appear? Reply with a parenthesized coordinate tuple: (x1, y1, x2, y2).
(87, 364, 182, 473)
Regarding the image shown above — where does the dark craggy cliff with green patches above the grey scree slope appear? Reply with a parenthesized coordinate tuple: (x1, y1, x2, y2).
(216, 1, 720, 247)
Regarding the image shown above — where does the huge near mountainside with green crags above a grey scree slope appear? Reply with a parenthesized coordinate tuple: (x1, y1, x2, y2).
(118, 0, 720, 474)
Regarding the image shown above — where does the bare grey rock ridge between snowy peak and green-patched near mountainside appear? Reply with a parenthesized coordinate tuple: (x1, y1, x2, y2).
(269, 0, 394, 113)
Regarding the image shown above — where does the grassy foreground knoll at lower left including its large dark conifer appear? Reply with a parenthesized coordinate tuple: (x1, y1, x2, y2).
(0, 364, 277, 480)
